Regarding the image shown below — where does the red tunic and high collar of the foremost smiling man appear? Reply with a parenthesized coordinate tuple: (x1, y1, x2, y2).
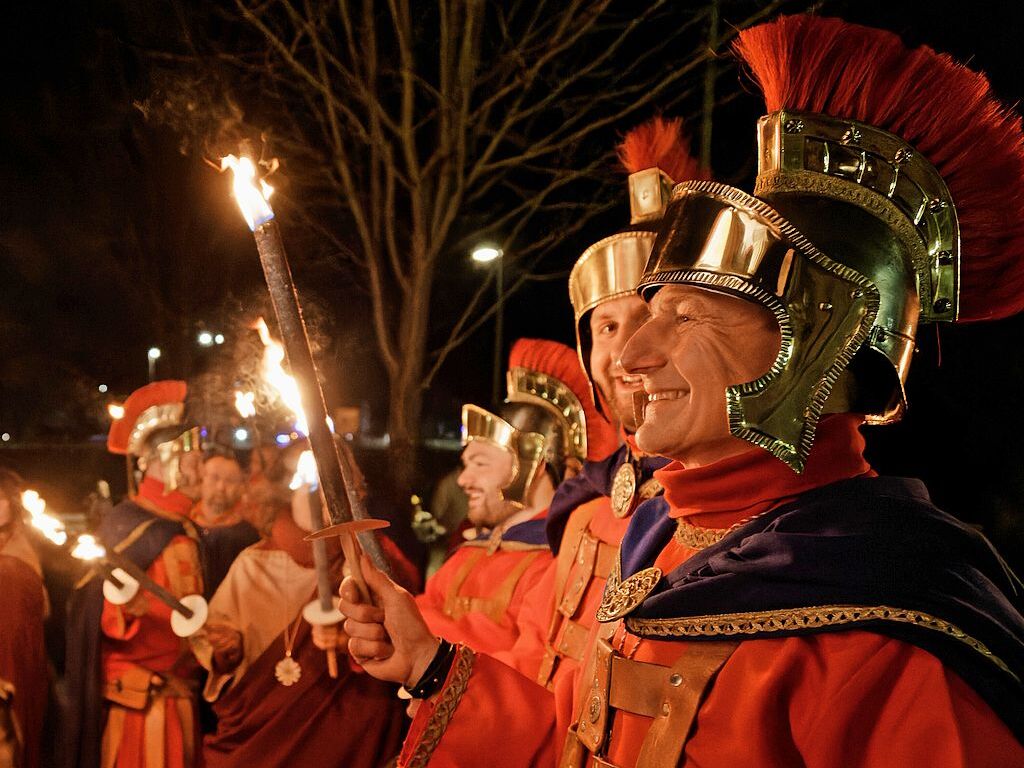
(401, 417, 1024, 768)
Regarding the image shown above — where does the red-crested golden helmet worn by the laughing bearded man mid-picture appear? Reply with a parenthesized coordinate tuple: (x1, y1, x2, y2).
(462, 339, 613, 507)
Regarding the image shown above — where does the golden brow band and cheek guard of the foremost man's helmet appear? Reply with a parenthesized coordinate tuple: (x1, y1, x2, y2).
(638, 181, 880, 472)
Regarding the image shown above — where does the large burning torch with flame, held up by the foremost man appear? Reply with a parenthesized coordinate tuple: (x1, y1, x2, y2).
(221, 156, 390, 589)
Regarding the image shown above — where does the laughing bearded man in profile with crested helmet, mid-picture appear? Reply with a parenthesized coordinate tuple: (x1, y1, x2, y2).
(407, 339, 593, 652)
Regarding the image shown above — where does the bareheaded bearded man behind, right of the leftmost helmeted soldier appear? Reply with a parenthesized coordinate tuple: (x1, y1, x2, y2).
(191, 450, 259, 598)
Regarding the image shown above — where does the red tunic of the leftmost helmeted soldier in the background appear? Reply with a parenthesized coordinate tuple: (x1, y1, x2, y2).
(100, 478, 203, 768)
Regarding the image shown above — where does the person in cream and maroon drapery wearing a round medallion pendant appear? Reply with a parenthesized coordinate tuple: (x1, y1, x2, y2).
(191, 442, 404, 768)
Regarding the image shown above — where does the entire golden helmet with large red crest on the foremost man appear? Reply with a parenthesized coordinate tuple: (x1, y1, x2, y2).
(639, 16, 1024, 471)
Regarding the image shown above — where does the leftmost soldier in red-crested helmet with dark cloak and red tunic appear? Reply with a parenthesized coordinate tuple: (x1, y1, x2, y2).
(66, 381, 203, 768)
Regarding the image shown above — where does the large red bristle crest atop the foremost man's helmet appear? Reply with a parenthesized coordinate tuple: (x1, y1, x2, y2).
(734, 15, 1024, 321)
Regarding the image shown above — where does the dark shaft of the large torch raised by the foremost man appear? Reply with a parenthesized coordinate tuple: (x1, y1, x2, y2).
(253, 219, 390, 572)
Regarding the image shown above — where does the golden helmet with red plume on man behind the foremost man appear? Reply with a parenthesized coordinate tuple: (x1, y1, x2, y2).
(569, 117, 707, 413)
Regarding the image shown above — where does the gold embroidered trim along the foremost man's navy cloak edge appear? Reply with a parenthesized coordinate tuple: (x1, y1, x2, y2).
(626, 605, 1020, 682)
